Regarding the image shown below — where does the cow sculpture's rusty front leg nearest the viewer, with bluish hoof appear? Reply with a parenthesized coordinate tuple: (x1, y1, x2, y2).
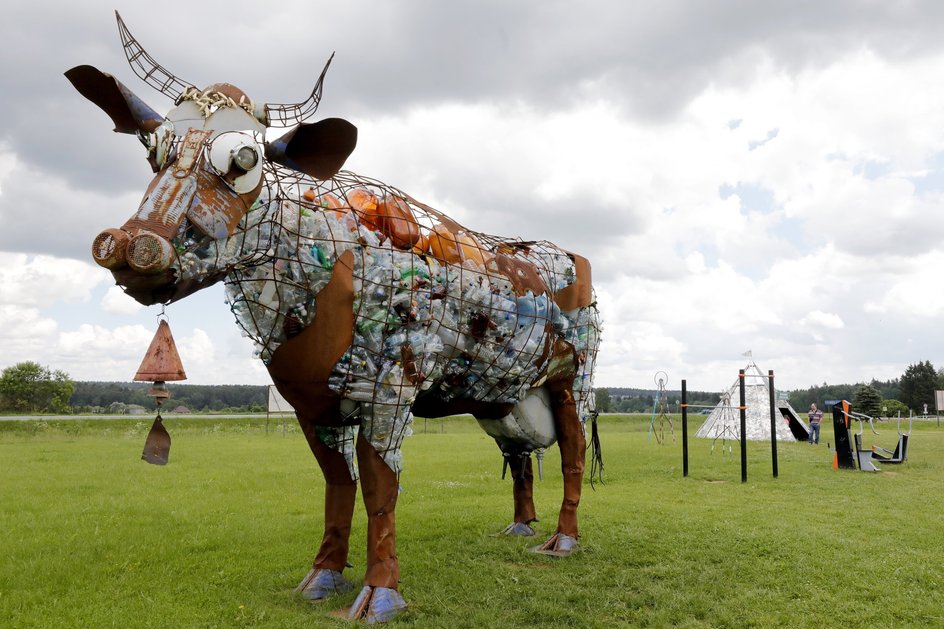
(348, 434, 406, 622)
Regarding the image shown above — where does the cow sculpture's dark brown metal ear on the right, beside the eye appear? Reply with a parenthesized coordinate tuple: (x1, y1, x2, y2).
(266, 118, 357, 179)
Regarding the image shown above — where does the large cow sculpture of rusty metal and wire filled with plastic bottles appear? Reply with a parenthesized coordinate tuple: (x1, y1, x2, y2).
(66, 16, 600, 621)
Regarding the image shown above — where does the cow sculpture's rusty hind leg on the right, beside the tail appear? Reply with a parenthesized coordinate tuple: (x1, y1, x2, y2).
(535, 384, 587, 555)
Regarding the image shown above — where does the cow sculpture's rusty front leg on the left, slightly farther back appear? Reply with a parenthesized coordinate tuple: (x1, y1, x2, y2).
(296, 422, 357, 601)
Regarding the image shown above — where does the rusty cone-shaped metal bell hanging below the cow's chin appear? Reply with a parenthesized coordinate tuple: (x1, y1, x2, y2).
(134, 319, 187, 465)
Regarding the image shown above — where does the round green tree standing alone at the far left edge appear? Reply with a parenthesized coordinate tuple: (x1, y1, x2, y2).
(0, 361, 75, 413)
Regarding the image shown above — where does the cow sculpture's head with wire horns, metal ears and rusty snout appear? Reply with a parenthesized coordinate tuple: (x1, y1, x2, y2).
(66, 13, 357, 305)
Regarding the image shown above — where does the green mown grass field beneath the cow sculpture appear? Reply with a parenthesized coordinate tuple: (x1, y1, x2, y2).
(0, 417, 944, 628)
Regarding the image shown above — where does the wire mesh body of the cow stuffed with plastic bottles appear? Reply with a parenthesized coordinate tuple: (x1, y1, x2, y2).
(175, 162, 600, 472)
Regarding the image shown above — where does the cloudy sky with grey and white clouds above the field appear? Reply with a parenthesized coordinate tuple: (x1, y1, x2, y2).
(0, 0, 944, 390)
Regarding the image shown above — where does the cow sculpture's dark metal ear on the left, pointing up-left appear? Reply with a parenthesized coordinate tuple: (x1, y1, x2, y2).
(66, 66, 164, 133)
